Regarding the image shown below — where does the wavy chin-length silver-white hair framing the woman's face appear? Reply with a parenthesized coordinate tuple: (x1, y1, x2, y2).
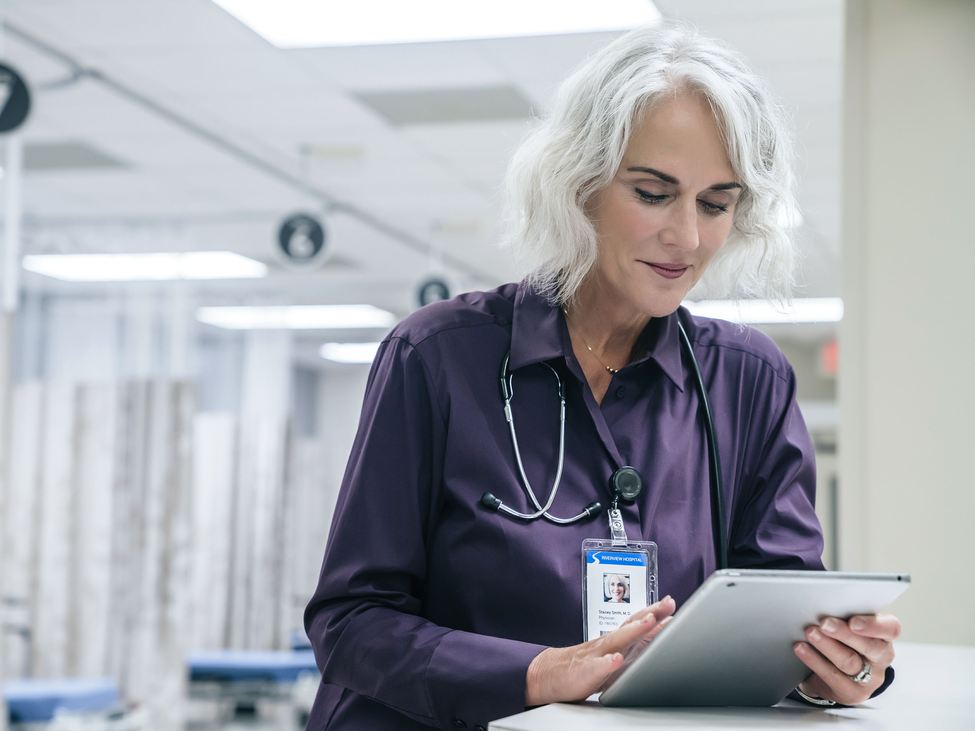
(503, 22, 797, 305)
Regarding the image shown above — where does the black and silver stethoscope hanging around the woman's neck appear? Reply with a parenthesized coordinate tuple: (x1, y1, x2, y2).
(480, 322, 728, 569)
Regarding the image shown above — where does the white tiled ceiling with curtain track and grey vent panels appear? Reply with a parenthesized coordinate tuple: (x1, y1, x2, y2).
(2, 0, 843, 315)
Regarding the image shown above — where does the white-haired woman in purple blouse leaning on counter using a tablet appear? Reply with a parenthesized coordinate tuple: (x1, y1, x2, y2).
(305, 20, 899, 730)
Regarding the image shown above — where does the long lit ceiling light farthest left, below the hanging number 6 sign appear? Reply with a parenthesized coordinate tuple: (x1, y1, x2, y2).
(23, 251, 267, 282)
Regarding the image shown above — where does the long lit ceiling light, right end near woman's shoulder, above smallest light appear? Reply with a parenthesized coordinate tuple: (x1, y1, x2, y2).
(196, 305, 396, 330)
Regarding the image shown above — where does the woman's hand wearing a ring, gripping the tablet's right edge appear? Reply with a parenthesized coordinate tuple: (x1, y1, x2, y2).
(793, 614, 901, 706)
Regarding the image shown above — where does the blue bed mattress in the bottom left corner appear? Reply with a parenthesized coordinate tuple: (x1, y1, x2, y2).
(3, 678, 119, 723)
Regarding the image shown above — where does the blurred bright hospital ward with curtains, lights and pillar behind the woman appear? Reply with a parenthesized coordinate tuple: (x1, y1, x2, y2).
(0, 0, 975, 729)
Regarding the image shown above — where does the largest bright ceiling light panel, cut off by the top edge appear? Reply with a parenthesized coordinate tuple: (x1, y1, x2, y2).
(213, 0, 661, 48)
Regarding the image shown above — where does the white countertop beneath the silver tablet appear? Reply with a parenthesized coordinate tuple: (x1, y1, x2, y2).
(489, 642, 975, 731)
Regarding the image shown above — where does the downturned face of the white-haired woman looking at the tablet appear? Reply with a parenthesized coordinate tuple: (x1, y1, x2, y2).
(587, 93, 741, 317)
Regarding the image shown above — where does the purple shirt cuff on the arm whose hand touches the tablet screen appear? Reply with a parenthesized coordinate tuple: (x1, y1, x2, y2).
(426, 630, 546, 729)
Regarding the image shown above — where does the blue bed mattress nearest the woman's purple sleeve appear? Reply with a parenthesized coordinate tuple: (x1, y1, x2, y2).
(186, 650, 318, 683)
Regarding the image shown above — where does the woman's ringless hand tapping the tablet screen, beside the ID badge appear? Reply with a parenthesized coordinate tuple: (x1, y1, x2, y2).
(525, 596, 677, 706)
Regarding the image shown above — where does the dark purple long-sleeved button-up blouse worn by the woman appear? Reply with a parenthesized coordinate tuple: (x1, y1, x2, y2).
(305, 284, 823, 731)
